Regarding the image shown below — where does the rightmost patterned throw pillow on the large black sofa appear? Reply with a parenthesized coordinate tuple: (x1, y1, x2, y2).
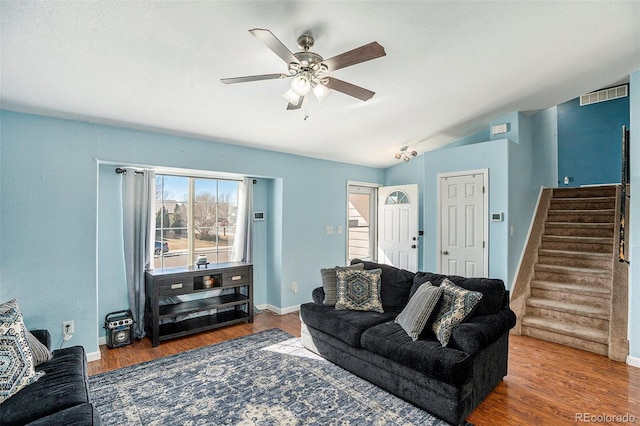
(431, 278, 482, 346)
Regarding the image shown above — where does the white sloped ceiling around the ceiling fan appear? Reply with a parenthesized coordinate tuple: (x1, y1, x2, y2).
(0, 0, 640, 167)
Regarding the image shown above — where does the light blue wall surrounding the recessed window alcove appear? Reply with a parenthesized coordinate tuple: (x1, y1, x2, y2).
(0, 111, 384, 352)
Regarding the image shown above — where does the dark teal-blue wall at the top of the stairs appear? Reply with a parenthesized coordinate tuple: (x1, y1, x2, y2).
(558, 93, 629, 187)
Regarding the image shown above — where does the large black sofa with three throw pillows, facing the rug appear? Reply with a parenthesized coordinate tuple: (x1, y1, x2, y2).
(300, 260, 516, 425)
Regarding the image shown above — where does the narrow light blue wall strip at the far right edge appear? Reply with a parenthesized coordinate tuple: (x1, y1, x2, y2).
(629, 70, 640, 366)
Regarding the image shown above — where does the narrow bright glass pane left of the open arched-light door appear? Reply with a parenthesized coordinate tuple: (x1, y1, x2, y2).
(347, 185, 377, 262)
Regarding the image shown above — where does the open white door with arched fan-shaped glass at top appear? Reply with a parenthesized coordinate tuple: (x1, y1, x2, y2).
(378, 185, 418, 272)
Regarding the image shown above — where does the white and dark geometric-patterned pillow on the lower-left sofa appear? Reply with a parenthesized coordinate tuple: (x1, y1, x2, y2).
(0, 299, 44, 403)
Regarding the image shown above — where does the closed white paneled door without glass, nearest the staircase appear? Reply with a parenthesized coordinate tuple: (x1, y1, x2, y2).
(439, 171, 487, 277)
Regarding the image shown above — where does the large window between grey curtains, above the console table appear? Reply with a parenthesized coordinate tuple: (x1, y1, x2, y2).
(153, 174, 240, 269)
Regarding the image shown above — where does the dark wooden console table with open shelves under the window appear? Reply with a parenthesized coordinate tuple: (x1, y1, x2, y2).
(145, 262, 253, 346)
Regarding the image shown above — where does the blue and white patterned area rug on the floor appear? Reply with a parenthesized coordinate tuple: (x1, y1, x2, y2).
(89, 329, 464, 426)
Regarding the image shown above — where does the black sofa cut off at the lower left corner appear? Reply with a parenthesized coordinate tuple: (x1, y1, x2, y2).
(0, 330, 102, 426)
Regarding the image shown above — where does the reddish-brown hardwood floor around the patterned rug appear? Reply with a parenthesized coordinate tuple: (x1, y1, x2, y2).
(89, 311, 640, 426)
